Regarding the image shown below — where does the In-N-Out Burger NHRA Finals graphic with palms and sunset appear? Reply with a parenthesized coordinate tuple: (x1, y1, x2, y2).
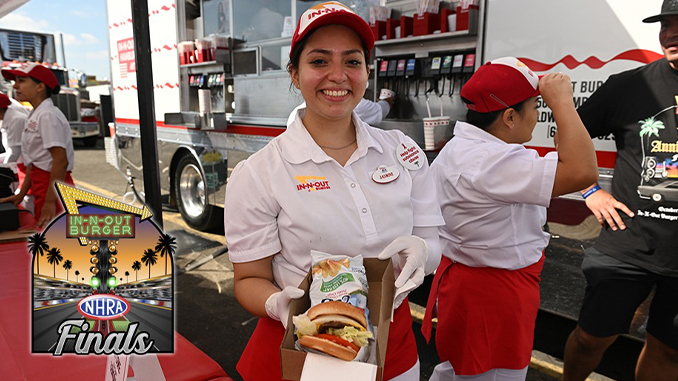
(31, 182, 176, 354)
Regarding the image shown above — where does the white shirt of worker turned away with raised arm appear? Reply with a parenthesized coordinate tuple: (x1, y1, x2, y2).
(431, 122, 558, 270)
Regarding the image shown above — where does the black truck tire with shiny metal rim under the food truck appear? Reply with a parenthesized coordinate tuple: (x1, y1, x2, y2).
(173, 155, 223, 231)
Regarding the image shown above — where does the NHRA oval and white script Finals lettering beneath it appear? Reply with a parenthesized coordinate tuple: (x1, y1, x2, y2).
(54, 294, 153, 356)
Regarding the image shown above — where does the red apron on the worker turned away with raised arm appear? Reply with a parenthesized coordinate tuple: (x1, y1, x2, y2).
(422, 255, 544, 376)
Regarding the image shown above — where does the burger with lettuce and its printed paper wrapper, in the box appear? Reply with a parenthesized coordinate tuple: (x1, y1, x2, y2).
(292, 251, 376, 364)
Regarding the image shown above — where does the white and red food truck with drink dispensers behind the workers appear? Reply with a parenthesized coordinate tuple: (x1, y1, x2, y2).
(107, 0, 662, 229)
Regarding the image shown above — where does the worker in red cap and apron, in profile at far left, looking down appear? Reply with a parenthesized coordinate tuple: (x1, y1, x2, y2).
(0, 63, 74, 228)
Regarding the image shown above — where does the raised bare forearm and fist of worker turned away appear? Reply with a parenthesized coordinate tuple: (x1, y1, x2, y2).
(539, 73, 598, 197)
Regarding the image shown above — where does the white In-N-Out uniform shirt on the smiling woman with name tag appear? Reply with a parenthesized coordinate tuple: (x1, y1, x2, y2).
(224, 109, 443, 288)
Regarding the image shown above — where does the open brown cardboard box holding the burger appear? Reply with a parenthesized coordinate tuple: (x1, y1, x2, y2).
(280, 258, 395, 381)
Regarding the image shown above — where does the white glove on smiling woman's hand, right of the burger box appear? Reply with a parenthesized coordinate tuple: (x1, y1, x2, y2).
(379, 235, 428, 309)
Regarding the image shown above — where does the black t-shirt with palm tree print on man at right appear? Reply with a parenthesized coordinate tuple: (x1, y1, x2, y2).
(578, 59, 678, 276)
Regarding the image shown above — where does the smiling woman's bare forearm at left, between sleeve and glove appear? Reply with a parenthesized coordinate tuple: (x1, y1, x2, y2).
(233, 256, 280, 317)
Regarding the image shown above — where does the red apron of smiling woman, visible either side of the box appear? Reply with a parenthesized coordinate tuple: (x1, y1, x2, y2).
(236, 299, 419, 381)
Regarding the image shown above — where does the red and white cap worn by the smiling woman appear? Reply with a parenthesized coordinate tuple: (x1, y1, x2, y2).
(290, 1, 374, 54)
